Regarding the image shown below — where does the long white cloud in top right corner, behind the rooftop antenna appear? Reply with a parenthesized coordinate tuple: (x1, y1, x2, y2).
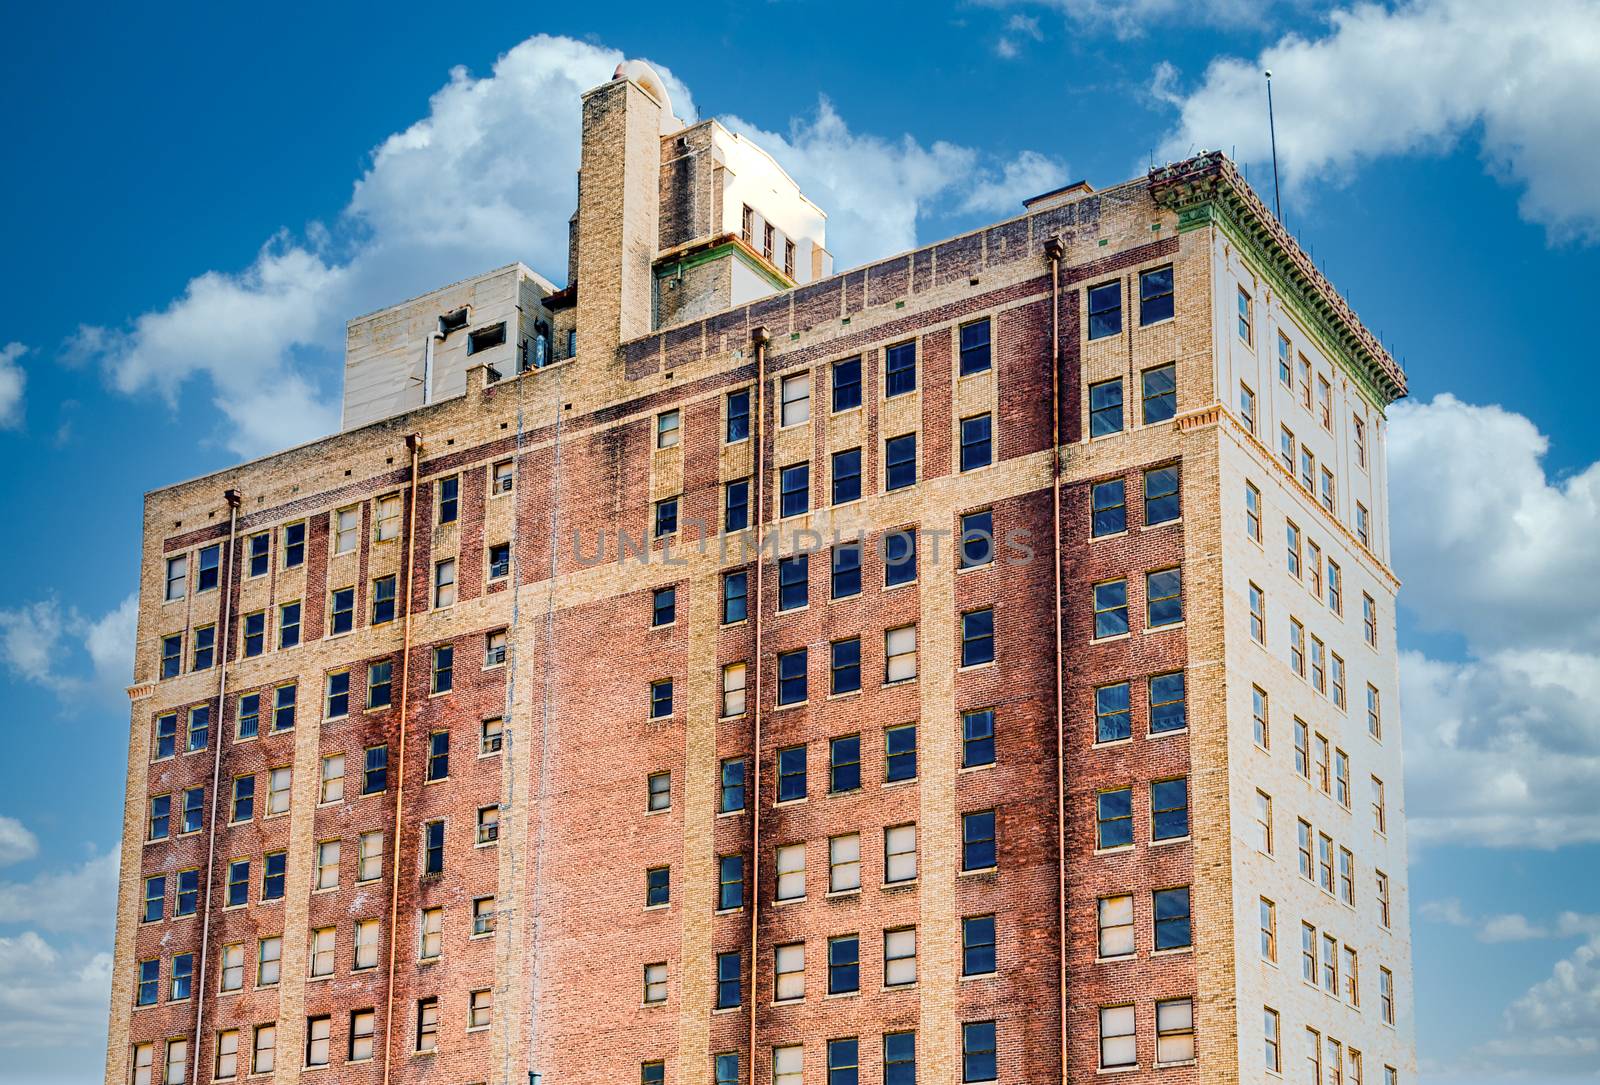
(1158, 0, 1600, 242)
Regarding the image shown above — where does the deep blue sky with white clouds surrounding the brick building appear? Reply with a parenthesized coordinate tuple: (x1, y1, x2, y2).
(0, 0, 1600, 1085)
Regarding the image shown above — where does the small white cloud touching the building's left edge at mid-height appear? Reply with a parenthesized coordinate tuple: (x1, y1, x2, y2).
(0, 594, 139, 698)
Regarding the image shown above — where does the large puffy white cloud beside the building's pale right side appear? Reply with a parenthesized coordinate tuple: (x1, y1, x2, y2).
(1389, 395, 1600, 848)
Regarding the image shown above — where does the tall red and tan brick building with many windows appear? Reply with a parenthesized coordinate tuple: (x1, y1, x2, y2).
(106, 64, 1416, 1085)
